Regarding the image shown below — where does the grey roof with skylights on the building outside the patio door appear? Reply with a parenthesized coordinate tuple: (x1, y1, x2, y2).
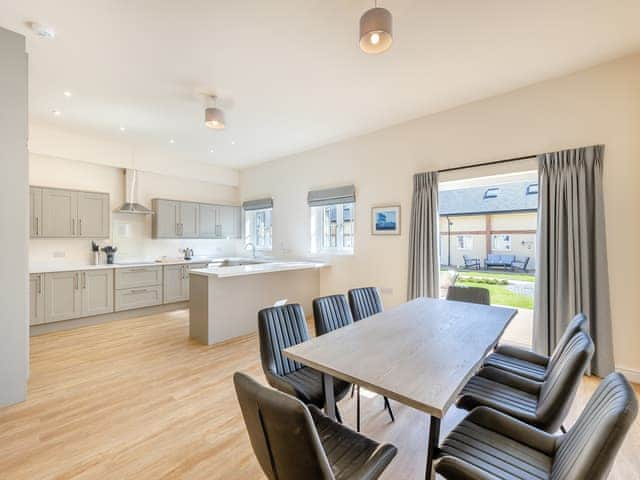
(438, 181, 538, 215)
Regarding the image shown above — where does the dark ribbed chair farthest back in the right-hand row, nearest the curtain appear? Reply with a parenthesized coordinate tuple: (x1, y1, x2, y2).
(484, 313, 588, 382)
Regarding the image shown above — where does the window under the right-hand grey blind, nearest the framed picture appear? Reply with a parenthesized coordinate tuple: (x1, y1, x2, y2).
(311, 203, 355, 254)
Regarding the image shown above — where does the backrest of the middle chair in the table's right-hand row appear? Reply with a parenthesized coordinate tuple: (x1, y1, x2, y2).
(536, 331, 594, 432)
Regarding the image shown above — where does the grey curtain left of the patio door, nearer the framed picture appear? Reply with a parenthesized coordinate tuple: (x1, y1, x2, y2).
(407, 172, 440, 300)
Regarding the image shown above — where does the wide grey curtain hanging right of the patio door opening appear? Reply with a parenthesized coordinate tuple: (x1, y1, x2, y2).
(533, 145, 614, 376)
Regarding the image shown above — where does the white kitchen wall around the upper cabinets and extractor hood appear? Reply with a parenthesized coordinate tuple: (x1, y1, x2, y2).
(29, 153, 239, 265)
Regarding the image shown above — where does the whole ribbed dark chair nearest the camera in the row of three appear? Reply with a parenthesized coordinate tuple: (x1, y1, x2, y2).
(258, 303, 349, 420)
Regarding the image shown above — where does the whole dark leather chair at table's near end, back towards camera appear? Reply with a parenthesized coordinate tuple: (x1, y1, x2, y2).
(233, 373, 397, 480)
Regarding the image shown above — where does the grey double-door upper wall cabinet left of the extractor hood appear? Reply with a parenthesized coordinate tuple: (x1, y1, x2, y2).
(29, 187, 110, 238)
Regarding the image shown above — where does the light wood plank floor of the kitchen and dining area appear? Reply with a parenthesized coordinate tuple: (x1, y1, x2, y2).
(0, 310, 640, 480)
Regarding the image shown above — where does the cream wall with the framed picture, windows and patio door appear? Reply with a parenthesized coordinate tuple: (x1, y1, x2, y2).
(240, 56, 640, 371)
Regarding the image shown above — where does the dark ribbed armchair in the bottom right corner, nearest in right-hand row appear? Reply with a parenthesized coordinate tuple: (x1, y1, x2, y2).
(435, 373, 638, 480)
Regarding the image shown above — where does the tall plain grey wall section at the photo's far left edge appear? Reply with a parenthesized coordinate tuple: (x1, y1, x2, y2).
(0, 28, 29, 405)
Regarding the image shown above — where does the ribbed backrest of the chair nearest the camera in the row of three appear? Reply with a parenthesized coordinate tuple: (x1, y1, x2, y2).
(258, 303, 309, 376)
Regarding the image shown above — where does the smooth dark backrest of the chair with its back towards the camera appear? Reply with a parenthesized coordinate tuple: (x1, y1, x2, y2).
(233, 372, 334, 480)
